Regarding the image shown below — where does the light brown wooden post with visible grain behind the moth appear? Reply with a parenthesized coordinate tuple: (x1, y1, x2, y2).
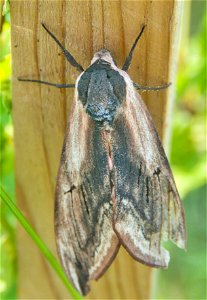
(11, 0, 181, 299)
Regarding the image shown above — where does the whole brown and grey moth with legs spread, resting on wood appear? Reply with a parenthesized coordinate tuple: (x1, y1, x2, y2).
(19, 24, 186, 295)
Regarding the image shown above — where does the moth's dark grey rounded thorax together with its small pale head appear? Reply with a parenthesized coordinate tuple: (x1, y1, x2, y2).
(78, 54, 126, 123)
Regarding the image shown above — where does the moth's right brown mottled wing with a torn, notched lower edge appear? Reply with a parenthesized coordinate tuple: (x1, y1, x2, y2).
(112, 81, 186, 267)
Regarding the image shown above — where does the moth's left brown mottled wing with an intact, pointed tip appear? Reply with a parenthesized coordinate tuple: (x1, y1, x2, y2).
(55, 96, 119, 294)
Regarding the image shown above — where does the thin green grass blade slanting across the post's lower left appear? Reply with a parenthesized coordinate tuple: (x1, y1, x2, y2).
(0, 186, 83, 299)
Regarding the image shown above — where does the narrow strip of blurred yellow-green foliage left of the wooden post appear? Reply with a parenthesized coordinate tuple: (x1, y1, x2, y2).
(0, 15, 17, 299)
